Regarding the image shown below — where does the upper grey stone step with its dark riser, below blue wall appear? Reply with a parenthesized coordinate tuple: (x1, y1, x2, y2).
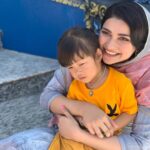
(0, 49, 58, 102)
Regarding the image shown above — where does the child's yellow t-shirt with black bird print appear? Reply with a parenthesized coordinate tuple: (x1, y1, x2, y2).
(67, 67, 137, 119)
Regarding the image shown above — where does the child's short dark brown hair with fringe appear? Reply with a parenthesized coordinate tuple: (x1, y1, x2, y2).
(58, 27, 99, 67)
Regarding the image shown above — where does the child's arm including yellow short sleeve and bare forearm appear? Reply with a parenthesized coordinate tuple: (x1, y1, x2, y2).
(114, 76, 138, 130)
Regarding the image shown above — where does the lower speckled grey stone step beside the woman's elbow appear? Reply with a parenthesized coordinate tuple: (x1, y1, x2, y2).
(0, 93, 51, 139)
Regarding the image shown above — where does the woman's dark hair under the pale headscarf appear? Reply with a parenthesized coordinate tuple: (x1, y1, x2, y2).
(101, 2, 148, 53)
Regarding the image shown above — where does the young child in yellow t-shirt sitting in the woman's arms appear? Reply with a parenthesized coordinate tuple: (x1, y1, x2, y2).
(49, 27, 137, 150)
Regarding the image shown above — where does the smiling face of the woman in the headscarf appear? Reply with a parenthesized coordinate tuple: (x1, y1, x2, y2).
(99, 17, 135, 65)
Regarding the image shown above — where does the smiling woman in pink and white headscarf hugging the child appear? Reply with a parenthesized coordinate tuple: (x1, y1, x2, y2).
(41, 2, 150, 150)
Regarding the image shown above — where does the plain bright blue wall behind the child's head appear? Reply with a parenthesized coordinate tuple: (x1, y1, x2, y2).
(0, 0, 84, 58)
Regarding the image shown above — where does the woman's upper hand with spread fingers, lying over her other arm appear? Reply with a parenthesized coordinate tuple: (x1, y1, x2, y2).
(79, 105, 117, 138)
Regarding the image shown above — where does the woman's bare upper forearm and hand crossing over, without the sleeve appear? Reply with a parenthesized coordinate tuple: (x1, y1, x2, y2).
(50, 96, 116, 137)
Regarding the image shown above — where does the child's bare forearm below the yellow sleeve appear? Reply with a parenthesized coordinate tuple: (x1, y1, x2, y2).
(114, 113, 136, 131)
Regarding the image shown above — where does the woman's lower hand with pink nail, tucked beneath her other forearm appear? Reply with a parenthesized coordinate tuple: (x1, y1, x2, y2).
(58, 108, 81, 140)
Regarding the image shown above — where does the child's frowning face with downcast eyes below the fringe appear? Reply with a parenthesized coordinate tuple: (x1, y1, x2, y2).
(67, 53, 101, 83)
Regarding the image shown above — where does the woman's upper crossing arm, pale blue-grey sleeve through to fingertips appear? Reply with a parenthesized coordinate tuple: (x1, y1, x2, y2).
(40, 68, 114, 136)
